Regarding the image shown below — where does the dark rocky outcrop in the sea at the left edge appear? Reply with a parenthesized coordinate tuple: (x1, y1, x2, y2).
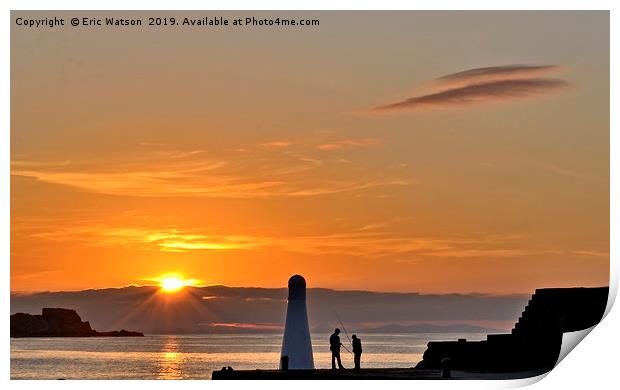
(11, 308, 144, 337)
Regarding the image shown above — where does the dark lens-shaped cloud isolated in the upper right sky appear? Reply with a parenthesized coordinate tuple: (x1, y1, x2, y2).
(371, 65, 568, 113)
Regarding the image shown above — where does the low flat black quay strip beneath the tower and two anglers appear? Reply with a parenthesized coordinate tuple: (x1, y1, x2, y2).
(211, 368, 548, 380)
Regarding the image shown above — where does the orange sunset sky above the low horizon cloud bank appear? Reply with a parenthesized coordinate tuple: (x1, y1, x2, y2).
(11, 12, 609, 294)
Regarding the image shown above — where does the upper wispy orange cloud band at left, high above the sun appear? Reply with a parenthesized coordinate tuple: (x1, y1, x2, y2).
(11, 149, 411, 198)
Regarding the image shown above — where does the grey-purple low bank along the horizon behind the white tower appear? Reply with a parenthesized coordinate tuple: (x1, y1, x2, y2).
(11, 286, 528, 334)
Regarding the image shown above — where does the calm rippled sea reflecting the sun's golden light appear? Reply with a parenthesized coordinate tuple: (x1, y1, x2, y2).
(11, 333, 486, 379)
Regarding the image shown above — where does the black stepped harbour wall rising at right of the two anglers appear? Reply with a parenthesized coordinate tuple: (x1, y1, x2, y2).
(416, 287, 609, 371)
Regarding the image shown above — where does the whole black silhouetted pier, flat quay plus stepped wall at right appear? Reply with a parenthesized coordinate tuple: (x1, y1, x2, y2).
(211, 287, 609, 379)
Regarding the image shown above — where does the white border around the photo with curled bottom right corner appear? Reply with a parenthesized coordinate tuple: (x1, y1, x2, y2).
(0, 0, 620, 390)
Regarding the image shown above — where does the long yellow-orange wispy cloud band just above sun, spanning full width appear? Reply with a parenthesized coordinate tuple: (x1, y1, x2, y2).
(12, 216, 609, 262)
